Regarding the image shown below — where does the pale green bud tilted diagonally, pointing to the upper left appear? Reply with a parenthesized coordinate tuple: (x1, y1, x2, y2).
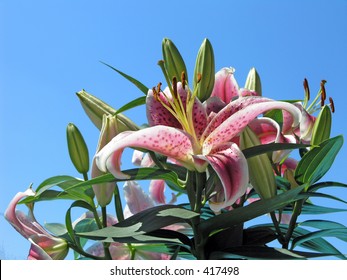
(77, 90, 139, 131)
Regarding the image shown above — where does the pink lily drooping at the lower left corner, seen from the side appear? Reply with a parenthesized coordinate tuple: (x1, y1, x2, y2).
(5, 188, 68, 260)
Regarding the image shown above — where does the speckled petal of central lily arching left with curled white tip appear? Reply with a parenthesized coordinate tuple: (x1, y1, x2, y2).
(95, 125, 194, 179)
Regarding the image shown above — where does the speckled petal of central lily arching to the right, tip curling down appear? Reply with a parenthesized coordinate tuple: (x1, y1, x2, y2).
(203, 97, 301, 154)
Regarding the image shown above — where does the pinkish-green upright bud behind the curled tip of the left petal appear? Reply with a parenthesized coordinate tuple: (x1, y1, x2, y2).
(92, 115, 119, 207)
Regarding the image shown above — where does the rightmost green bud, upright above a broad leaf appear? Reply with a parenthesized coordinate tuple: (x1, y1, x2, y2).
(311, 105, 332, 145)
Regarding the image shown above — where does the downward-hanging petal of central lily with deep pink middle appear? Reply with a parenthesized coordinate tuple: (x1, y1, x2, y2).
(198, 143, 249, 212)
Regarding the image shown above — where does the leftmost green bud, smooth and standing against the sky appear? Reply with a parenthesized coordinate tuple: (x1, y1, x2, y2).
(66, 123, 89, 174)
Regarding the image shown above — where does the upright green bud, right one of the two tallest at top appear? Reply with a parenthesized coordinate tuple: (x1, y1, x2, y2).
(194, 39, 215, 102)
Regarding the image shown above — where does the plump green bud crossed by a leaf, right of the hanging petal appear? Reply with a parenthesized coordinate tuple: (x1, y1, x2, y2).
(240, 127, 276, 199)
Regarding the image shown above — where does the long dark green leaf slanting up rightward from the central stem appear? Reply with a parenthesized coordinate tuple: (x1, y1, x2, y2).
(199, 185, 305, 236)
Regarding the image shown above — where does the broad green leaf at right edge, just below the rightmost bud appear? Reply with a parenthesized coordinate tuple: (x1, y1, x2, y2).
(295, 135, 343, 185)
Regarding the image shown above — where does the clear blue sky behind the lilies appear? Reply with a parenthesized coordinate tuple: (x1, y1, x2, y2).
(0, 0, 347, 259)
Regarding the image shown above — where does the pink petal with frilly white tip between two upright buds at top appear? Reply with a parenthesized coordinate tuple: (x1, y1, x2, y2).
(211, 67, 239, 103)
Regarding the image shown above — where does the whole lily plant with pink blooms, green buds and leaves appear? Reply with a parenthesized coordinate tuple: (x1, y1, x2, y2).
(5, 38, 347, 260)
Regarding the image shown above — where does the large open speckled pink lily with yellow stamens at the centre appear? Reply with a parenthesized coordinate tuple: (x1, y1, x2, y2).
(95, 80, 300, 212)
